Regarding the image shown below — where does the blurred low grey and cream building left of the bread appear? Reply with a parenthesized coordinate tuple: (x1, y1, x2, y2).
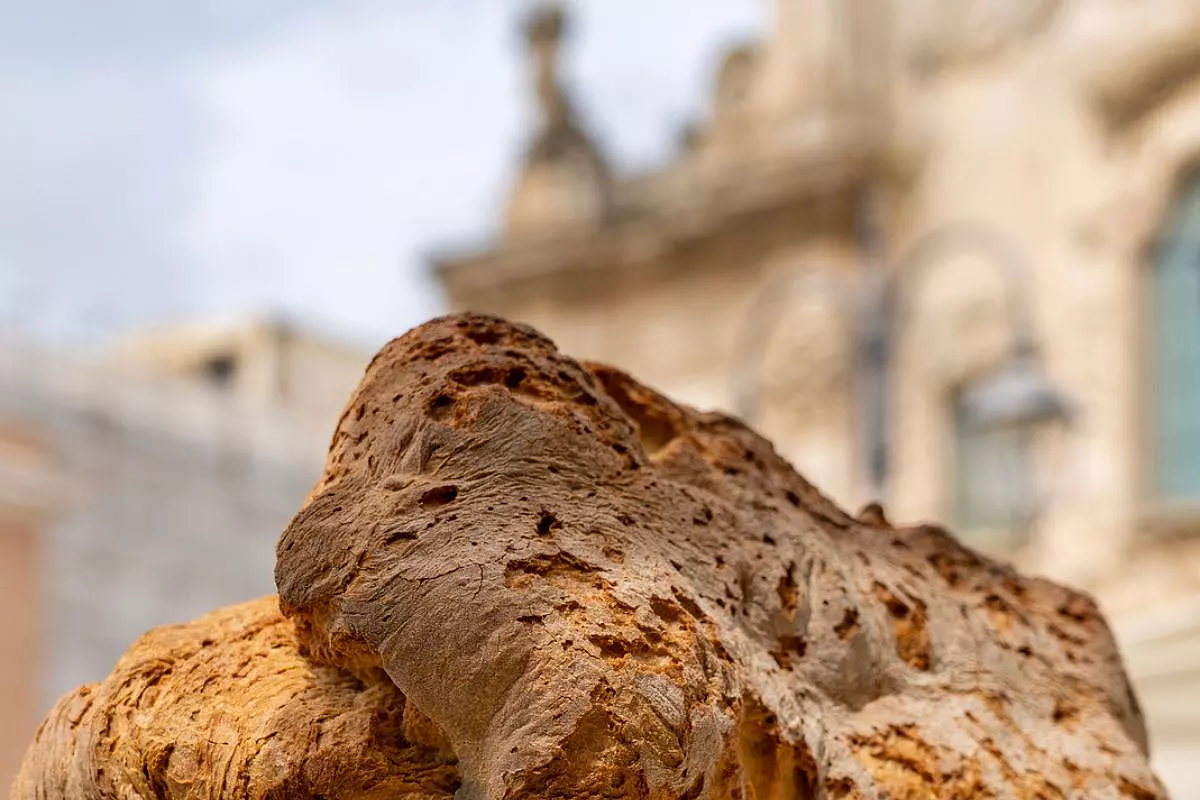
(0, 321, 368, 787)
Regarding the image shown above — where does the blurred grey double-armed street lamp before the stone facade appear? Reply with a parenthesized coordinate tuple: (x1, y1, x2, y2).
(734, 223, 1072, 500)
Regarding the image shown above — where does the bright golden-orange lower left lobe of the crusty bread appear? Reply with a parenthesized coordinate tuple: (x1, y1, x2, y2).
(12, 597, 458, 800)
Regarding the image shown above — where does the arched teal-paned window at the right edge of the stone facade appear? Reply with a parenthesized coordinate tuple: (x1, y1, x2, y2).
(1146, 173, 1200, 503)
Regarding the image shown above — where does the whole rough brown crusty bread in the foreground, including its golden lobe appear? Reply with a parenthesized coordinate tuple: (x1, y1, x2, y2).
(16, 314, 1165, 800)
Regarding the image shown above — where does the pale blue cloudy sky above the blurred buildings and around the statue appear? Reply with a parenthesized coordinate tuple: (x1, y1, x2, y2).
(0, 0, 769, 343)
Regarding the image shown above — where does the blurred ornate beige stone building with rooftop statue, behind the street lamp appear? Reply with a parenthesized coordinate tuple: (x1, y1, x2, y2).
(436, 0, 1200, 798)
